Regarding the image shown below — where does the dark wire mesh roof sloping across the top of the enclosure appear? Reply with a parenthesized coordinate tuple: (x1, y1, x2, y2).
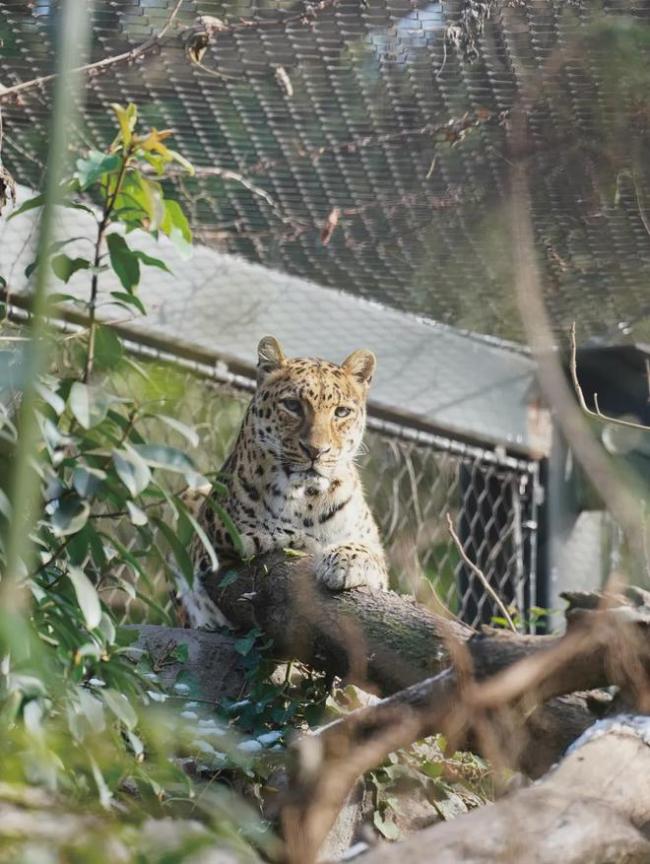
(0, 0, 650, 342)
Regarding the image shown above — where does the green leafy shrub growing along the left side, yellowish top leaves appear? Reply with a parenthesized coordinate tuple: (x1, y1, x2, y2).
(0, 105, 270, 861)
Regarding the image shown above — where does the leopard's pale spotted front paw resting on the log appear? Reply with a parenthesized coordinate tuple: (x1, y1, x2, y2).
(316, 543, 388, 591)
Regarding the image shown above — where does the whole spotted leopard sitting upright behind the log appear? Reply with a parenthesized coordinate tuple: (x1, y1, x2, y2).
(181, 336, 388, 629)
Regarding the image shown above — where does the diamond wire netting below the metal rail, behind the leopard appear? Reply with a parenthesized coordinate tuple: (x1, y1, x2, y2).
(100, 364, 538, 628)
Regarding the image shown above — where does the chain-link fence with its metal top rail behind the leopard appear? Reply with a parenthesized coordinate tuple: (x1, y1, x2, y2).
(0, 306, 541, 631)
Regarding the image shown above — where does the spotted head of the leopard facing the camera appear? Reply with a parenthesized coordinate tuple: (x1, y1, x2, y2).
(250, 336, 376, 480)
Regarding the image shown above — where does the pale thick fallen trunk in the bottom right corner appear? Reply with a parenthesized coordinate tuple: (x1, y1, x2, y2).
(363, 717, 650, 864)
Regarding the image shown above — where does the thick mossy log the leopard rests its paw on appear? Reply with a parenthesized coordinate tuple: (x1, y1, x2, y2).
(205, 553, 475, 695)
